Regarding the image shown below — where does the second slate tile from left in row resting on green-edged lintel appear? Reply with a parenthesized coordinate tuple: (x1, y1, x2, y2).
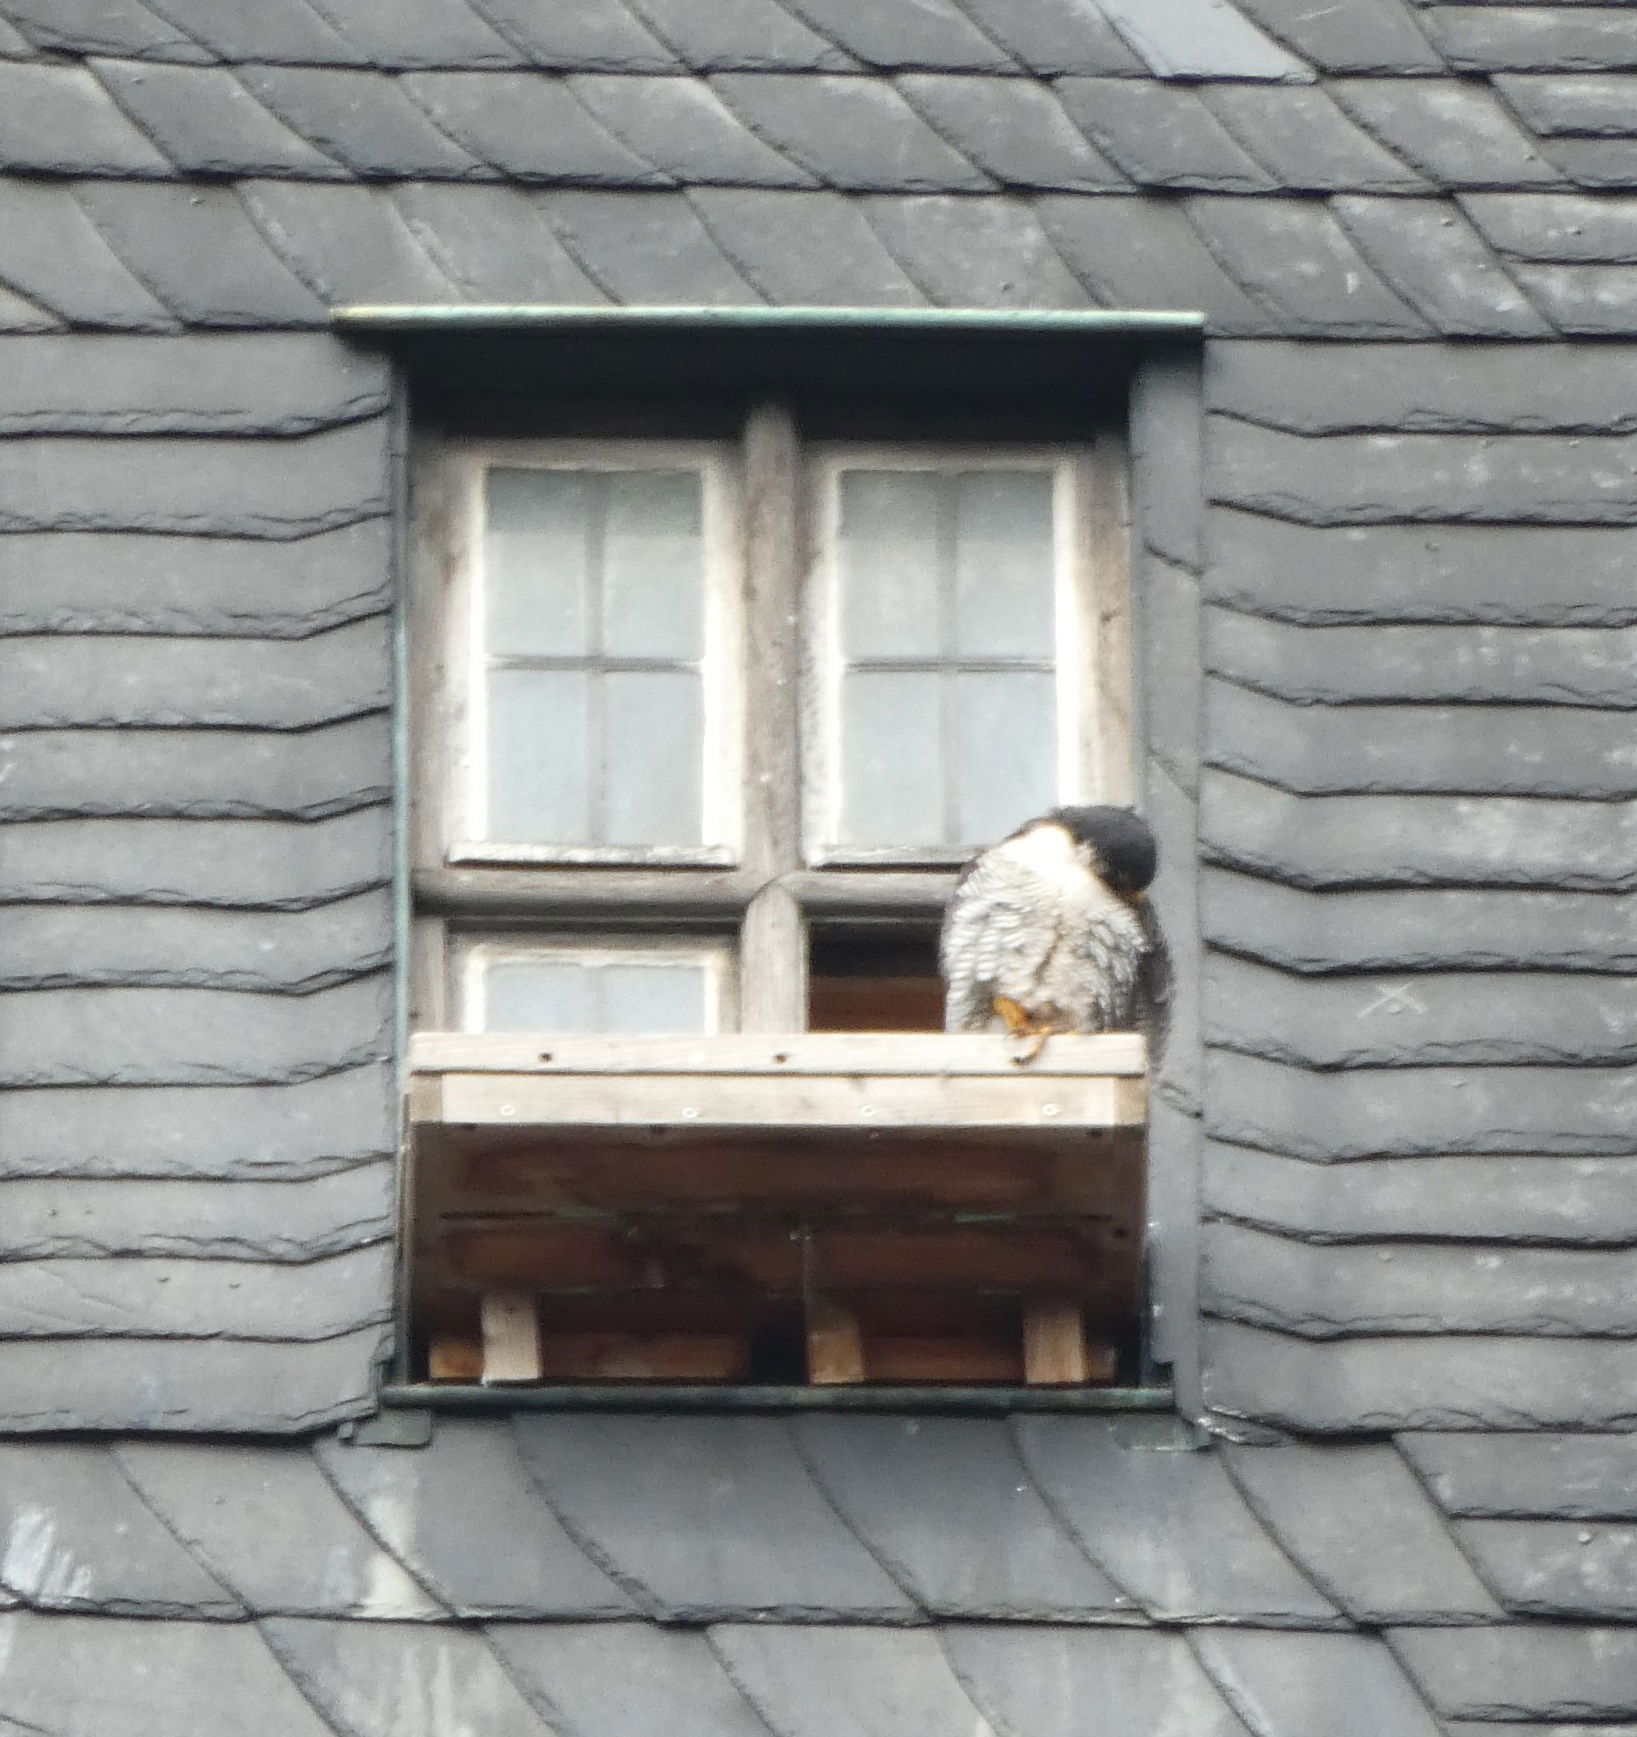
(393, 181, 606, 306)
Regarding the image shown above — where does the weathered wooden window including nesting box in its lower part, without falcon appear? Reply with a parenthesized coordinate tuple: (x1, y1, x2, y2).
(403, 345, 1149, 1390)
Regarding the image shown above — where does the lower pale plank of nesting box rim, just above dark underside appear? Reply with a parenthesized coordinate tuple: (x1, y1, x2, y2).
(432, 1073, 1147, 1129)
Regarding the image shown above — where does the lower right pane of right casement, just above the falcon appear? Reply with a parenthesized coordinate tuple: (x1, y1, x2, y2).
(951, 674, 1057, 846)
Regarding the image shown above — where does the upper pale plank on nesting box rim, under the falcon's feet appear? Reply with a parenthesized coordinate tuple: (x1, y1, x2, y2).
(408, 1032, 1147, 1082)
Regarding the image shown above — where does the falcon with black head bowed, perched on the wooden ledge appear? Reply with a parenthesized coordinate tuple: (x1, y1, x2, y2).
(938, 808, 1170, 1061)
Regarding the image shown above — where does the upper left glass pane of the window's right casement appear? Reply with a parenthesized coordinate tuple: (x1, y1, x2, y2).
(836, 471, 945, 658)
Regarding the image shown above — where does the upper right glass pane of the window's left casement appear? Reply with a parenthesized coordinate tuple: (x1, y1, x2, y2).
(603, 471, 706, 658)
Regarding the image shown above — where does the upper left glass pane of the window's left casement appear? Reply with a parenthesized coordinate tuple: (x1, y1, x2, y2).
(483, 471, 591, 657)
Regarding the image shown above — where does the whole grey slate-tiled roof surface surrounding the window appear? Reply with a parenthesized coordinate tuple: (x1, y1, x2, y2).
(0, 0, 1637, 1737)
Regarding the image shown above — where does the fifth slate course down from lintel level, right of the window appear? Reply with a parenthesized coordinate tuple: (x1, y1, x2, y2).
(1204, 681, 1637, 805)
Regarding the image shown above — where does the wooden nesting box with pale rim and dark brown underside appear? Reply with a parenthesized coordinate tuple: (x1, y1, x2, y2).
(408, 1032, 1145, 1384)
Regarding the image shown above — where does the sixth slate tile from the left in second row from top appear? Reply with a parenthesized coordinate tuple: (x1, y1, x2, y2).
(711, 73, 992, 193)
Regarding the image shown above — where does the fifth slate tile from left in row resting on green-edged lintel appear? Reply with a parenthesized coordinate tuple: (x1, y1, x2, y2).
(862, 193, 1090, 307)
